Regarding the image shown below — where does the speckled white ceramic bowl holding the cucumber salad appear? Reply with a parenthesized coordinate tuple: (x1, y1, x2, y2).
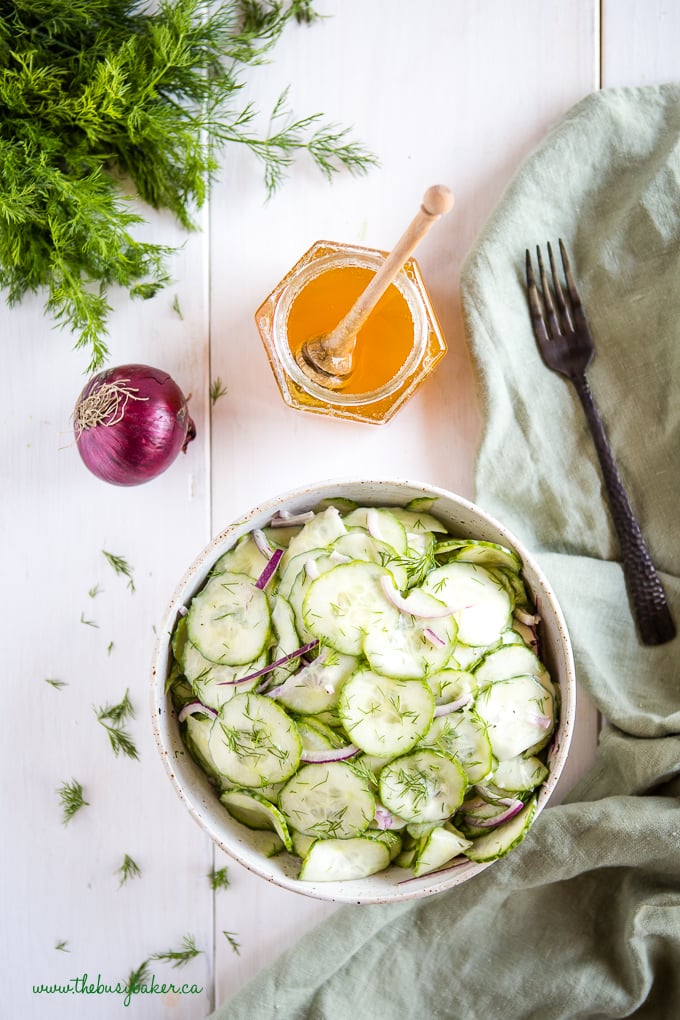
(152, 480, 576, 904)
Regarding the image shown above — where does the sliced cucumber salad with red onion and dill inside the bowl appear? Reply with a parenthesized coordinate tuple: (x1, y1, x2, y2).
(168, 499, 559, 882)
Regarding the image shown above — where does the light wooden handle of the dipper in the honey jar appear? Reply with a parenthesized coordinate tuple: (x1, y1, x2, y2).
(322, 185, 454, 355)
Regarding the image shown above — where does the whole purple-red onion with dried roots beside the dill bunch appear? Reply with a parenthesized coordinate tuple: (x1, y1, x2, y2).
(73, 365, 196, 486)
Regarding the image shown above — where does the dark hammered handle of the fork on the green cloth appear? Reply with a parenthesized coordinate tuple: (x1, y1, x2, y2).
(572, 373, 676, 645)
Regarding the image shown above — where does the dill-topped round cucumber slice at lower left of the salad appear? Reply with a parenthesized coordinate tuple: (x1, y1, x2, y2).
(208, 694, 302, 787)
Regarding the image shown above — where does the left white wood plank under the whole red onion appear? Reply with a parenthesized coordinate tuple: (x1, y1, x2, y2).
(0, 202, 213, 1020)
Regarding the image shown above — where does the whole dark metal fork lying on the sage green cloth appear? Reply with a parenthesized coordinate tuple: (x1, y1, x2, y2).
(526, 241, 676, 645)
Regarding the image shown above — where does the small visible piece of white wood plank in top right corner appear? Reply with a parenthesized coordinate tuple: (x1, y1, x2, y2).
(601, 0, 680, 88)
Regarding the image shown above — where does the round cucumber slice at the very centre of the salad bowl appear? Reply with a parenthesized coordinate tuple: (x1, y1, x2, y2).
(337, 669, 434, 758)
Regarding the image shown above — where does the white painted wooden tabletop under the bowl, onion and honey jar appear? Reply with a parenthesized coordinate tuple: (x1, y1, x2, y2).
(0, 0, 680, 1020)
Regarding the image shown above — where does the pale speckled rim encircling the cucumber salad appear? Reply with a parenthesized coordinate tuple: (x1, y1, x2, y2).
(150, 477, 576, 904)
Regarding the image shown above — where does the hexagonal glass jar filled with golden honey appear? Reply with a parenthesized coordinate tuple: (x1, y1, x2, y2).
(255, 241, 447, 424)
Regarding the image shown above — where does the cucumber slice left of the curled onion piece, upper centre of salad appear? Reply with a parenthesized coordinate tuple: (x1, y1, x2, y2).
(302, 561, 400, 656)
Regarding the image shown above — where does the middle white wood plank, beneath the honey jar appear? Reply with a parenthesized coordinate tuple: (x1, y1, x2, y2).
(211, 0, 598, 1002)
